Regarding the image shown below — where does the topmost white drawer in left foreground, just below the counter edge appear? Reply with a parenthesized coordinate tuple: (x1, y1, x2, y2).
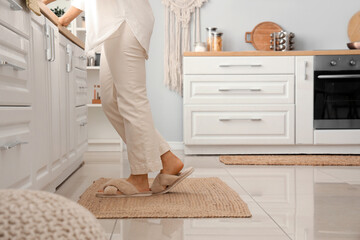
(0, 0, 30, 37)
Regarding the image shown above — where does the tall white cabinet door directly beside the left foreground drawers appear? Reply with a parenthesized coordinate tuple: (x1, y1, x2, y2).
(31, 15, 51, 188)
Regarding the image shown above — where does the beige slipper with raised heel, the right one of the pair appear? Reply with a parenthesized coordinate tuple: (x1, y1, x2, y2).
(151, 167, 194, 195)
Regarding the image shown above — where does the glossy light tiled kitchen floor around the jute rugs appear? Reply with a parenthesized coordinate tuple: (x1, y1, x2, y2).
(57, 151, 360, 240)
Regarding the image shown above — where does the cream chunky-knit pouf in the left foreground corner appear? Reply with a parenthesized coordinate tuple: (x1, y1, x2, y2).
(0, 189, 106, 240)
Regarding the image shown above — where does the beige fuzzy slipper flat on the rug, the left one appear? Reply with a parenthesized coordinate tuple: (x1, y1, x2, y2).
(95, 179, 152, 198)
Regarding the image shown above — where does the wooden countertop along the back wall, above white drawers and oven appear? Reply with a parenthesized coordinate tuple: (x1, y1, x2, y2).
(184, 49, 360, 57)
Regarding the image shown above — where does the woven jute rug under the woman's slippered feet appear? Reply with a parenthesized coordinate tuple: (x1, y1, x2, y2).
(78, 178, 251, 218)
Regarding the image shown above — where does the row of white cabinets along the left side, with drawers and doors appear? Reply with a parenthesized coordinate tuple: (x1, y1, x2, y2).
(0, 0, 87, 190)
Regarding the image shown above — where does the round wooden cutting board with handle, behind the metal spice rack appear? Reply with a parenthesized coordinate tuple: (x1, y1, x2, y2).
(245, 22, 283, 51)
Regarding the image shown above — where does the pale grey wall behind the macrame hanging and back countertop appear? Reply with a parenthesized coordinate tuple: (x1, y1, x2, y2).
(147, 0, 360, 141)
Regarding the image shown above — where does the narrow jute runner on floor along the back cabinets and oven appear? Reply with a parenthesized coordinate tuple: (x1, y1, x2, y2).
(219, 155, 360, 166)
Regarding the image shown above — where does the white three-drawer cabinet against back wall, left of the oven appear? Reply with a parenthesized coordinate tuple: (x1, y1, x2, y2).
(184, 56, 295, 154)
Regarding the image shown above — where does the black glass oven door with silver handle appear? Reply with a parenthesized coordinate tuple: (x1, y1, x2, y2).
(314, 71, 360, 129)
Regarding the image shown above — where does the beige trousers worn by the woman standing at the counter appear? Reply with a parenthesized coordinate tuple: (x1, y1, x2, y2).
(100, 22, 170, 175)
